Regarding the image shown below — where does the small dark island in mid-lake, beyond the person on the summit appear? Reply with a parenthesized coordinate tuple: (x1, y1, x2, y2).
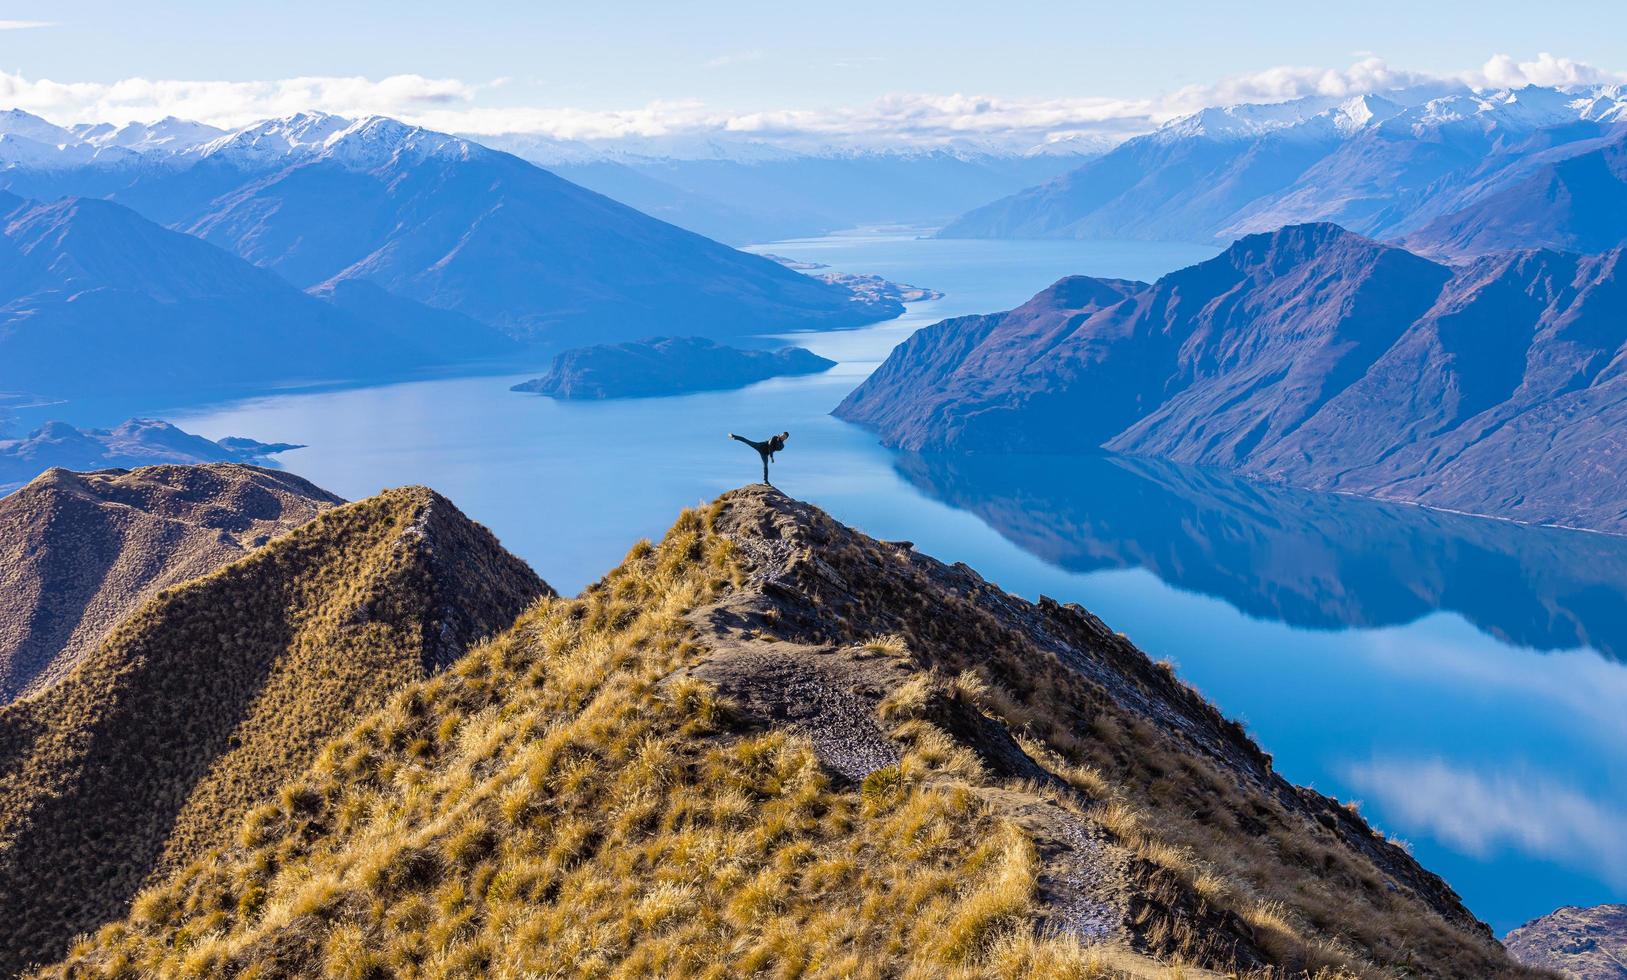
(513, 337, 836, 399)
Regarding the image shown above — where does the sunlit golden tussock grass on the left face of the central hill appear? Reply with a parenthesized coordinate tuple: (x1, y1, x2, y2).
(46, 511, 1116, 978)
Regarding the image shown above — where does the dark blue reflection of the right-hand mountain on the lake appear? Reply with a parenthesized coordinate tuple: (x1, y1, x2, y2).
(896, 454, 1627, 661)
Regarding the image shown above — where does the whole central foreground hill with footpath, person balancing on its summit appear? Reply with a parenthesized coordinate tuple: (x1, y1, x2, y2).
(34, 488, 1546, 980)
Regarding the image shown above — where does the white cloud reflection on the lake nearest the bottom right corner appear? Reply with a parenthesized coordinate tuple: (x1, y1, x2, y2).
(1346, 759, 1627, 887)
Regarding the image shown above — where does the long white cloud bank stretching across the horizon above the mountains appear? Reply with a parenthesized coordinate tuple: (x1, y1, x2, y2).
(0, 52, 1627, 148)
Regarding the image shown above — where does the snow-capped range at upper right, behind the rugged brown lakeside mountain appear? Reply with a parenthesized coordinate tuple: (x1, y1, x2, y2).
(939, 86, 1627, 256)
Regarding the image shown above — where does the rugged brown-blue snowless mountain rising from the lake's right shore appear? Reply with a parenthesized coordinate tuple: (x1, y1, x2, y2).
(836, 223, 1627, 531)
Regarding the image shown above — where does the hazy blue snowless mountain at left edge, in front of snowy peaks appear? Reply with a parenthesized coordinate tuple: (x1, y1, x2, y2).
(0, 192, 485, 399)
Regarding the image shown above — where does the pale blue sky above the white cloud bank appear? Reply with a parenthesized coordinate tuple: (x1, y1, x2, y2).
(0, 0, 1627, 140)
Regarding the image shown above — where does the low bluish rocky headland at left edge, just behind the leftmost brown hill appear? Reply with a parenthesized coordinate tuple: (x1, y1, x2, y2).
(0, 418, 301, 493)
